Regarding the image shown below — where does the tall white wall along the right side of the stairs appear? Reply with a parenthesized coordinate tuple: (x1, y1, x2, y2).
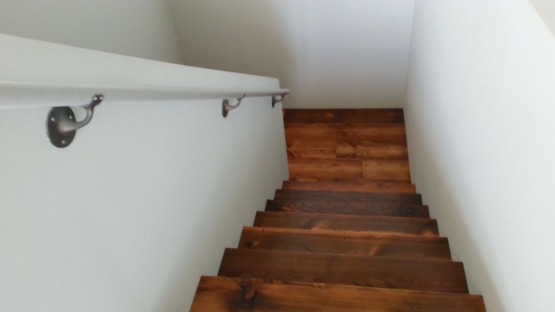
(405, 0, 555, 312)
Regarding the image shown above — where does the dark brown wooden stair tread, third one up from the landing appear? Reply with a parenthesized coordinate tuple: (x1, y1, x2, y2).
(266, 199, 430, 218)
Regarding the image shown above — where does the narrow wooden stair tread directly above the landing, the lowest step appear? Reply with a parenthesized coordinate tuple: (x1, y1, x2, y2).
(282, 179, 416, 194)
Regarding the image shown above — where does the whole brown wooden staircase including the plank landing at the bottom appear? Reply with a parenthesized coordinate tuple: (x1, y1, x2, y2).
(191, 110, 485, 312)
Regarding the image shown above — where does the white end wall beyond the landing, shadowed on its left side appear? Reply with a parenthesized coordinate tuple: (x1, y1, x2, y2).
(169, 0, 414, 108)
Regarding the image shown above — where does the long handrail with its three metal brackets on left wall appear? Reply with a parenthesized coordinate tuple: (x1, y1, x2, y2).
(0, 81, 289, 148)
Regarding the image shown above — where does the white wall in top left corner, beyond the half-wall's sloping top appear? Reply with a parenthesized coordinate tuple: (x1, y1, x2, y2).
(0, 0, 183, 64)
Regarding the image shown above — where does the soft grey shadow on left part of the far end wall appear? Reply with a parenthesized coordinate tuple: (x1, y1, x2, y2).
(169, 0, 299, 98)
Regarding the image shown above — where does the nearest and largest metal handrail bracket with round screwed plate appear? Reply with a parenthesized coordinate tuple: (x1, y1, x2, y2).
(46, 94, 104, 148)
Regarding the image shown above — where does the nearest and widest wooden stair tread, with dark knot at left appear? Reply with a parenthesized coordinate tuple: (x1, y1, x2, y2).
(191, 276, 486, 312)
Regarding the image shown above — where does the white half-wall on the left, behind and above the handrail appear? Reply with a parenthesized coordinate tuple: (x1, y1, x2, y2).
(0, 36, 287, 312)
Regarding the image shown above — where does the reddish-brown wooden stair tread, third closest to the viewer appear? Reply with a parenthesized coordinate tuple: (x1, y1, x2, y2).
(239, 227, 451, 260)
